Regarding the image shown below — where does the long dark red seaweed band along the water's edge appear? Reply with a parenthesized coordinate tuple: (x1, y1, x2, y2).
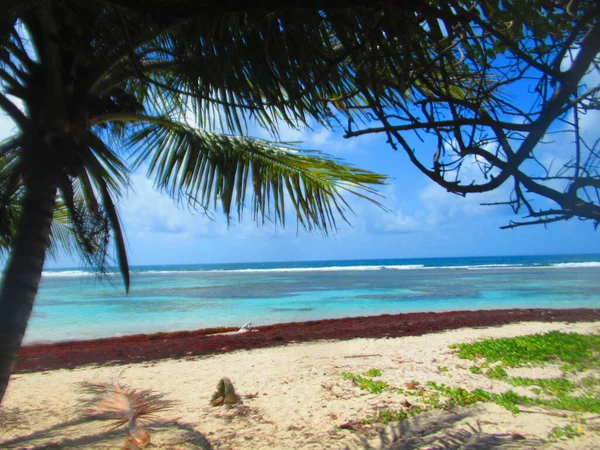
(15, 309, 600, 373)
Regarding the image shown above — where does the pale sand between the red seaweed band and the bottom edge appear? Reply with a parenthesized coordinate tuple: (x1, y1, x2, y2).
(0, 322, 600, 449)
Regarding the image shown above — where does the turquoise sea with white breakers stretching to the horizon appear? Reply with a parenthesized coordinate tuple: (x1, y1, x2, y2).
(25, 255, 600, 343)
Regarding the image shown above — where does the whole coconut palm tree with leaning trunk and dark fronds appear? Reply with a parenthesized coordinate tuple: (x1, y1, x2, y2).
(0, 0, 394, 399)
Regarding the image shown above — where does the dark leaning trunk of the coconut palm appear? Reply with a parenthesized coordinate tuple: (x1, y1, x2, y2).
(0, 168, 57, 403)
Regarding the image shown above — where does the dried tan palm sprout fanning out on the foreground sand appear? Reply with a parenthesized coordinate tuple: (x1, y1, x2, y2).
(81, 382, 173, 449)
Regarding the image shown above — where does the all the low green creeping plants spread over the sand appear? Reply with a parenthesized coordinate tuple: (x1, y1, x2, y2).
(342, 332, 600, 440)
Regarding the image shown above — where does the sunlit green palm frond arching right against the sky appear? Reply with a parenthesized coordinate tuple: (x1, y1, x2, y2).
(129, 118, 385, 233)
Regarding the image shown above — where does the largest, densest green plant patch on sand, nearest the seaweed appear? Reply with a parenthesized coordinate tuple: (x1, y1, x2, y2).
(452, 331, 600, 367)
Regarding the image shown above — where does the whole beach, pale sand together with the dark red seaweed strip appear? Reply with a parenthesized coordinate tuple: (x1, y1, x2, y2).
(0, 309, 600, 449)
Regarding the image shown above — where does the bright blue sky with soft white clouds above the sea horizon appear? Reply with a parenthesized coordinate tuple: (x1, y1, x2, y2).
(0, 89, 600, 268)
